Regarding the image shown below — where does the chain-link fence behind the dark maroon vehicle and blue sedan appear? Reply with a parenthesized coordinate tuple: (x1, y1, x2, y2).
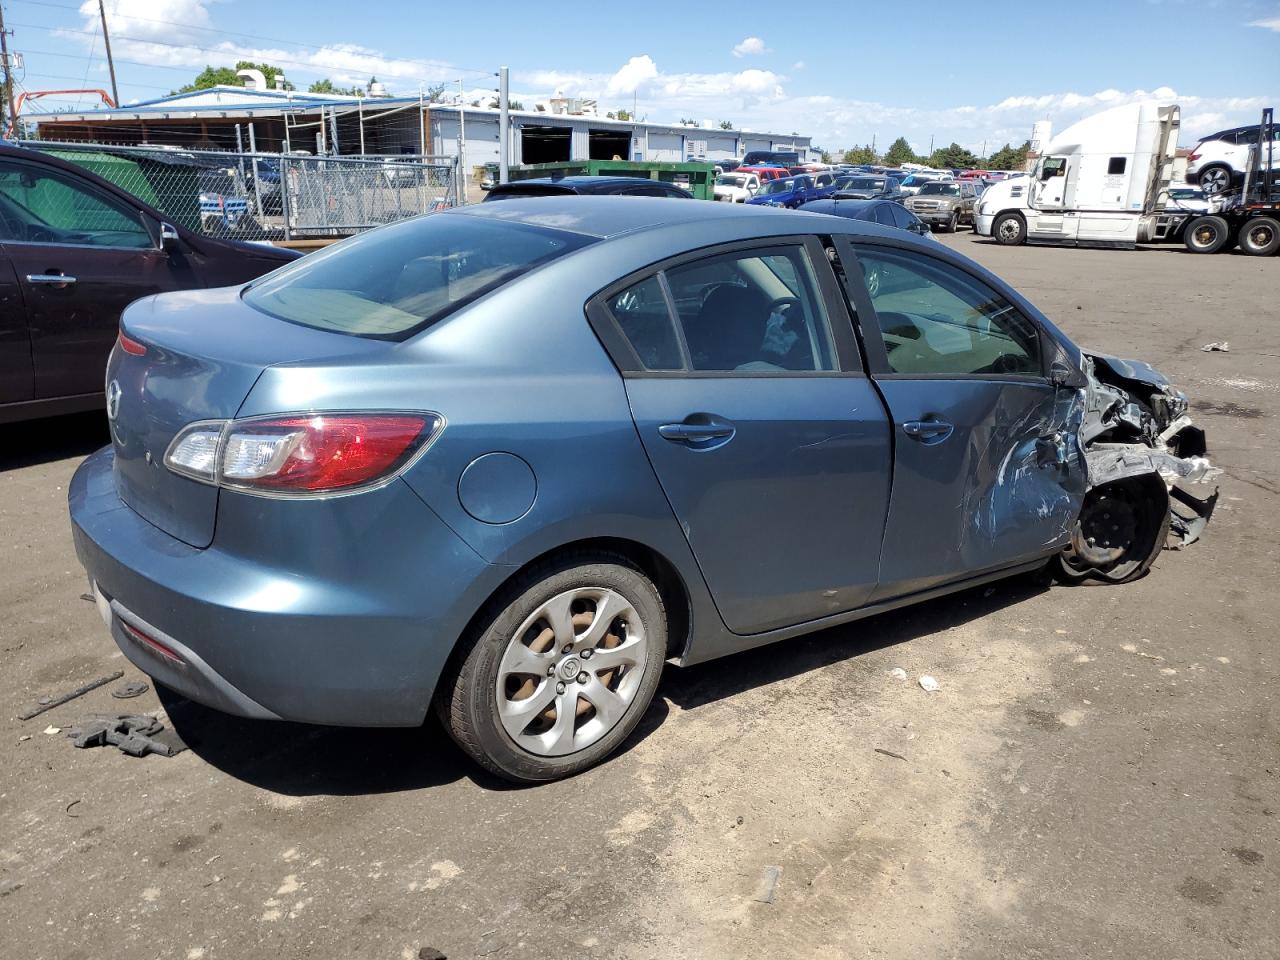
(22, 141, 465, 241)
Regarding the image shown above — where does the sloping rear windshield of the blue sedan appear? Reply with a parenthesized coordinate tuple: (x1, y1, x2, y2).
(243, 214, 594, 340)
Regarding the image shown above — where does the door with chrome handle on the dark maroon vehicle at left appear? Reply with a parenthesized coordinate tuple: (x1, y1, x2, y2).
(0, 157, 174, 399)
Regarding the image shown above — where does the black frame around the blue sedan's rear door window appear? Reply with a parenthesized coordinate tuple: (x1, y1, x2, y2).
(584, 234, 868, 380)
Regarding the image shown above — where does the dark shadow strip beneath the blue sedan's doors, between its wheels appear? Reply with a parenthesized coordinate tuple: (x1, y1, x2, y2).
(658, 576, 1048, 710)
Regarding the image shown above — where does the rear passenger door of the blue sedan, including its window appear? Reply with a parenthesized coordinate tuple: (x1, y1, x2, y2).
(589, 238, 891, 635)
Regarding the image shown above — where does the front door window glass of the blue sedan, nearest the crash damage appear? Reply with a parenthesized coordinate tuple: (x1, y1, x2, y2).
(858, 247, 1042, 376)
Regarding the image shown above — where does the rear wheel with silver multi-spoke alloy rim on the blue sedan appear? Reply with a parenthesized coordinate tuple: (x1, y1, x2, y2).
(436, 553, 667, 783)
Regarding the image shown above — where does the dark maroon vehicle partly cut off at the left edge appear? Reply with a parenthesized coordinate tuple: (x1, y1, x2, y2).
(0, 146, 298, 424)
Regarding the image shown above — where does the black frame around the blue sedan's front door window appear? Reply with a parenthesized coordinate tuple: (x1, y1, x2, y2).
(835, 234, 1059, 384)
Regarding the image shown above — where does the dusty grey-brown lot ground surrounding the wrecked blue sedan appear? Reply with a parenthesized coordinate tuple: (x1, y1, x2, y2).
(0, 233, 1280, 960)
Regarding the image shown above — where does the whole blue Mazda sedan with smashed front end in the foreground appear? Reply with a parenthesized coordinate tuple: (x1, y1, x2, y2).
(69, 196, 1211, 781)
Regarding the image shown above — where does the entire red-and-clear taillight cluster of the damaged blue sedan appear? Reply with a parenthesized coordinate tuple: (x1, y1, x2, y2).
(164, 413, 442, 497)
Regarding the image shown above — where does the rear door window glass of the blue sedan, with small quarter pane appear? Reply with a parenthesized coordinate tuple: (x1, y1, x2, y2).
(608, 246, 836, 375)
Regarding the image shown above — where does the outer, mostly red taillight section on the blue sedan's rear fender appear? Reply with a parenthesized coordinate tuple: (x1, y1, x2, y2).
(219, 413, 438, 493)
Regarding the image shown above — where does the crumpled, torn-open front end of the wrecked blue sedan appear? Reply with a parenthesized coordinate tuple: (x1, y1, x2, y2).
(1062, 353, 1221, 582)
